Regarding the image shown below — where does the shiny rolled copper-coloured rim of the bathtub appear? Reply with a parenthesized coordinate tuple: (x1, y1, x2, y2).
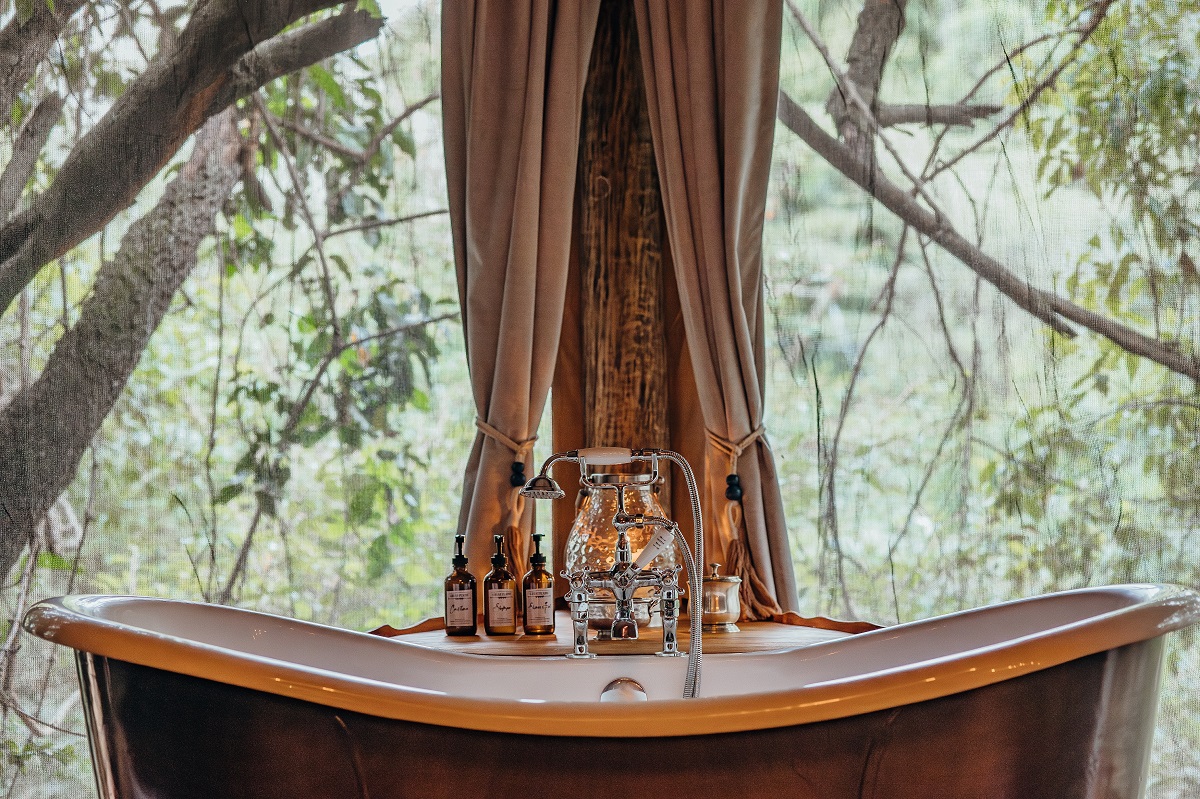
(23, 583, 1200, 738)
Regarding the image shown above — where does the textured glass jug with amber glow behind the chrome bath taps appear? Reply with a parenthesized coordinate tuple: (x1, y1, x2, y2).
(565, 474, 683, 638)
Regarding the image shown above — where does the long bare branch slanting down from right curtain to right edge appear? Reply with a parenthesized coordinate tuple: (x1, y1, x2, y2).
(779, 91, 1200, 383)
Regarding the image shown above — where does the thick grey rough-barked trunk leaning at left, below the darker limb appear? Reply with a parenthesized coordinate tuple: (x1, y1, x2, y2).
(0, 110, 240, 576)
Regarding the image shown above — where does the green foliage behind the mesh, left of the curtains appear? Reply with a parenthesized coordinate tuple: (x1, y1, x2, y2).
(0, 2, 460, 795)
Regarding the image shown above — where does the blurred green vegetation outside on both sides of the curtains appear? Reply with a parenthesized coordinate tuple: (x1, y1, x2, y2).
(0, 0, 1200, 799)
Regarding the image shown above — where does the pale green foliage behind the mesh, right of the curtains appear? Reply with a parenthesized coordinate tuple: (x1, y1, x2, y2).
(764, 0, 1200, 798)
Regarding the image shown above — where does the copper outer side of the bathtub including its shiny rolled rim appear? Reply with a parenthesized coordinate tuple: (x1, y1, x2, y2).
(25, 587, 1198, 799)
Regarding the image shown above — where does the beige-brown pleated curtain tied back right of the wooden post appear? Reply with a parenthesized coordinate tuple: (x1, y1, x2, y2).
(635, 0, 799, 618)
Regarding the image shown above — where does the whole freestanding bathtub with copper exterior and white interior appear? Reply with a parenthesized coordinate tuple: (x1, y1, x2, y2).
(24, 585, 1200, 799)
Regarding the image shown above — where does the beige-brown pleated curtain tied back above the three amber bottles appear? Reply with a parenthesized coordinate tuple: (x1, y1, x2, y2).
(442, 0, 599, 575)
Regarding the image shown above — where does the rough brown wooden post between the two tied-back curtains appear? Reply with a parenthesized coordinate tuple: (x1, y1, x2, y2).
(578, 0, 670, 458)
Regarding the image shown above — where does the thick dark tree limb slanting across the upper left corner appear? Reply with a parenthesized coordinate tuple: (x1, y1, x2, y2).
(0, 0, 369, 314)
